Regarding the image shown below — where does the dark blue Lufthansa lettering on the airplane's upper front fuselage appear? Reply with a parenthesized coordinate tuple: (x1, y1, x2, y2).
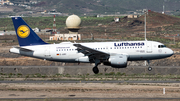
(114, 42, 144, 46)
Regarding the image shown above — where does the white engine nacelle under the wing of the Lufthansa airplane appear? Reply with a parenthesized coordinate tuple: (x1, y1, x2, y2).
(104, 54, 127, 68)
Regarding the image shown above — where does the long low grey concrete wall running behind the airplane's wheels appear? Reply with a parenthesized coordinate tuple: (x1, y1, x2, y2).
(0, 66, 180, 75)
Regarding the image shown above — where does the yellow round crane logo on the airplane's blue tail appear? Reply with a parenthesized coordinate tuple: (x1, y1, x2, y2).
(17, 25, 30, 38)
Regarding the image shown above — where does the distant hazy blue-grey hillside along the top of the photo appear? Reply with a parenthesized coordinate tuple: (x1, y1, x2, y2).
(10, 0, 180, 15)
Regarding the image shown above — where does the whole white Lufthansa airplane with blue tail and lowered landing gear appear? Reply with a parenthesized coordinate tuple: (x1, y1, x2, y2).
(10, 17, 173, 74)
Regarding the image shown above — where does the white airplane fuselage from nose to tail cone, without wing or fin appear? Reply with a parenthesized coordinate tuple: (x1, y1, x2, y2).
(10, 41, 173, 62)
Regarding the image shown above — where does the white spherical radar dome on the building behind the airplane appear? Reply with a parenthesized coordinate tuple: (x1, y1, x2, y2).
(66, 15, 81, 29)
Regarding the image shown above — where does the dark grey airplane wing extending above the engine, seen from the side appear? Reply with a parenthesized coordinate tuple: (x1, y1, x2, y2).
(73, 44, 110, 60)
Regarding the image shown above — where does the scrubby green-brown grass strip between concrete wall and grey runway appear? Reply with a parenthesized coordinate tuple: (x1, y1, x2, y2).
(0, 72, 180, 81)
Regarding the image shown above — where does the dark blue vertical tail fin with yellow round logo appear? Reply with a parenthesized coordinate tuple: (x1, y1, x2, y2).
(12, 17, 47, 46)
